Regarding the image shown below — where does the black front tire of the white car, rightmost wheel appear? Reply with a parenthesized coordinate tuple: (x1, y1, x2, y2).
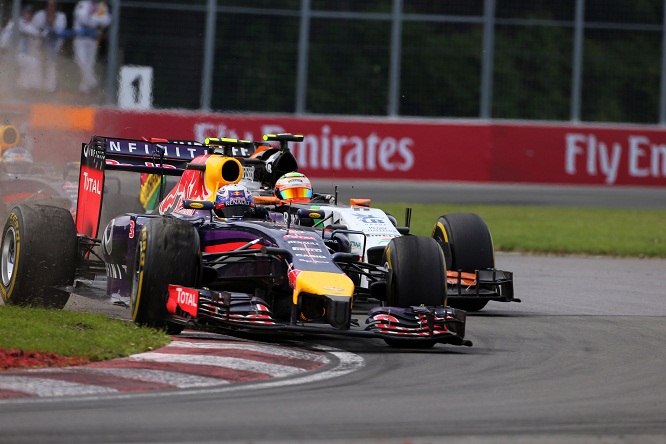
(432, 213, 495, 311)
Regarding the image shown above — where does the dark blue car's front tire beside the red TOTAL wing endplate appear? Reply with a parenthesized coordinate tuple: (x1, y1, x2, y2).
(130, 218, 201, 334)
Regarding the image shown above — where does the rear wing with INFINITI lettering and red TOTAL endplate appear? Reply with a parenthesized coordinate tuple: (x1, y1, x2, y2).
(76, 136, 208, 238)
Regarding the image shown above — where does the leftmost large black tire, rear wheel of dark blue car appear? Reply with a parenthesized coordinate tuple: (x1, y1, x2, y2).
(0, 204, 78, 309)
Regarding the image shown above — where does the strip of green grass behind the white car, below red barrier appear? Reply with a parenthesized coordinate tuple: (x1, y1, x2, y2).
(375, 203, 666, 258)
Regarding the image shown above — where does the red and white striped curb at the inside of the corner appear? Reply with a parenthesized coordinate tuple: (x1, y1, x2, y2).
(0, 337, 364, 401)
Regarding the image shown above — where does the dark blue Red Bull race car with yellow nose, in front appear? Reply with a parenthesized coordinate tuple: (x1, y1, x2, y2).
(0, 136, 471, 348)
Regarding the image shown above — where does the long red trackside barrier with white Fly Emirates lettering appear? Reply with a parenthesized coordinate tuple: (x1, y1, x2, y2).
(6, 105, 666, 186)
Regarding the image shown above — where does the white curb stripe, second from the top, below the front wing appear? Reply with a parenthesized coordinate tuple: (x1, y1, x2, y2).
(128, 352, 305, 378)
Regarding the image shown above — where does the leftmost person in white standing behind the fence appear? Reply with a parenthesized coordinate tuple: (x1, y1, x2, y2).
(0, 5, 41, 90)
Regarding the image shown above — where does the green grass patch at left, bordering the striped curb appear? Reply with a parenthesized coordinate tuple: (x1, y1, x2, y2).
(0, 305, 171, 361)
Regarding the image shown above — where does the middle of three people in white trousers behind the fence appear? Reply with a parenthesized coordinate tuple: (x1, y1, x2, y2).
(32, 0, 67, 92)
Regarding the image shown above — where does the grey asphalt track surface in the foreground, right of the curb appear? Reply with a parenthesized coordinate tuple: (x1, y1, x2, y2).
(0, 181, 666, 444)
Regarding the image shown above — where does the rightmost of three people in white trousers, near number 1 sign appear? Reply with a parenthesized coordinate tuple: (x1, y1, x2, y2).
(74, 0, 111, 94)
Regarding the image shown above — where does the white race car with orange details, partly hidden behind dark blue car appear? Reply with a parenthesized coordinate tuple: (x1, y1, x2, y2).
(233, 134, 520, 311)
